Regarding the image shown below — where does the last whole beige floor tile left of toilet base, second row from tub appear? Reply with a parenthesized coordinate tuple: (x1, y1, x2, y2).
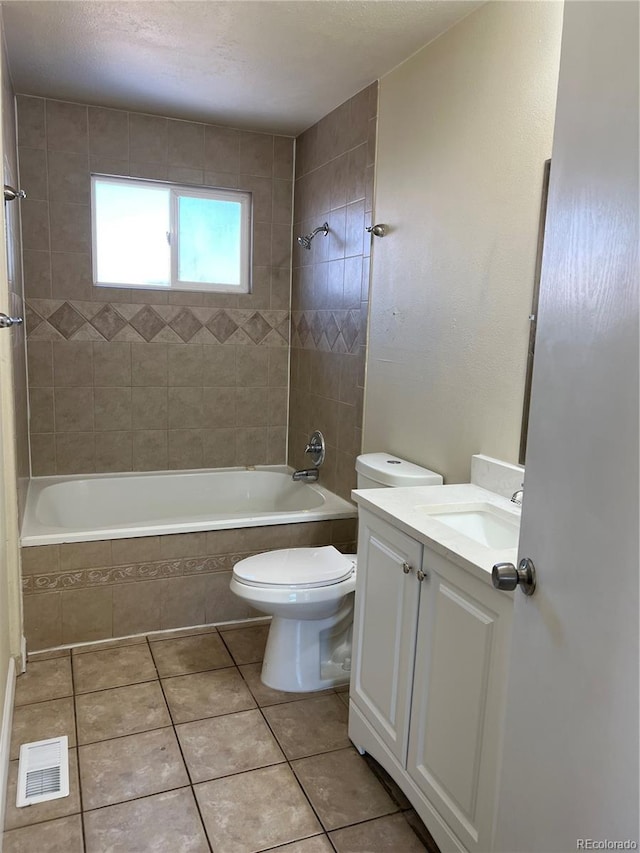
(162, 667, 256, 723)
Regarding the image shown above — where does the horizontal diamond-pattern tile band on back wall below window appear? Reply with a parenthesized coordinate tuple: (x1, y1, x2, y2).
(26, 299, 290, 347)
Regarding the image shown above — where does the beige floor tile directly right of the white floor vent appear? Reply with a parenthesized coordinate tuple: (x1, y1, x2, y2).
(78, 728, 189, 810)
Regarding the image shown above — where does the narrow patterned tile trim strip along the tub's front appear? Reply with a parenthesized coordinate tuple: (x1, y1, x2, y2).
(22, 551, 259, 595)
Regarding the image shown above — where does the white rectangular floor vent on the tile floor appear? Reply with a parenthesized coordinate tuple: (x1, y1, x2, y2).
(16, 735, 69, 808)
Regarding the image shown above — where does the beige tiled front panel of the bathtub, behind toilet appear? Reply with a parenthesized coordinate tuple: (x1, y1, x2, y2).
(22, 519, 355, 651)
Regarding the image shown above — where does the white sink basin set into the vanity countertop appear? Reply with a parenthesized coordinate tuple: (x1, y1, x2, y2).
(418, 503, 520, 548)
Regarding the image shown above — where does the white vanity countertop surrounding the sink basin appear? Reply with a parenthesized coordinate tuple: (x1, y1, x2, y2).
(351, 483, 520, 584)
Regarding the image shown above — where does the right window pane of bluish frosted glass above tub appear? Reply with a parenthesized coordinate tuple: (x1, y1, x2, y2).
(178, 196, 242, 286)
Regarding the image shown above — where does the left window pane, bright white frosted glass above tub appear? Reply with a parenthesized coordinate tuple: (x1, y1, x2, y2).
(95, 181, 171, 287)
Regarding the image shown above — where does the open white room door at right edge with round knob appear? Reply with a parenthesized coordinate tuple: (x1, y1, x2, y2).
(496, 2, 640, 853)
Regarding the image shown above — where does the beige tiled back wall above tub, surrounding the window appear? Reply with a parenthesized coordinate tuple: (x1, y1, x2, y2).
(18, 96, 293, 476)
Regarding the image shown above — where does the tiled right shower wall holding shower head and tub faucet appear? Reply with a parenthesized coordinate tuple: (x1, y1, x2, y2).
(289, 83, 378, 498)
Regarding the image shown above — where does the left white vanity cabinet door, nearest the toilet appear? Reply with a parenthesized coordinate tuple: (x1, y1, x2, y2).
(351, 510, 422, 765)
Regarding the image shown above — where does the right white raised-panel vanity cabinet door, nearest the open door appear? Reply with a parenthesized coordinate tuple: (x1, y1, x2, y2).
(407, 548, 512, 853)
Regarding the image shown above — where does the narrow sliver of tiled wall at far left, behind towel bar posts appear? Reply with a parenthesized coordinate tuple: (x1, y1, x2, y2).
(2, 56, 29, 523)
